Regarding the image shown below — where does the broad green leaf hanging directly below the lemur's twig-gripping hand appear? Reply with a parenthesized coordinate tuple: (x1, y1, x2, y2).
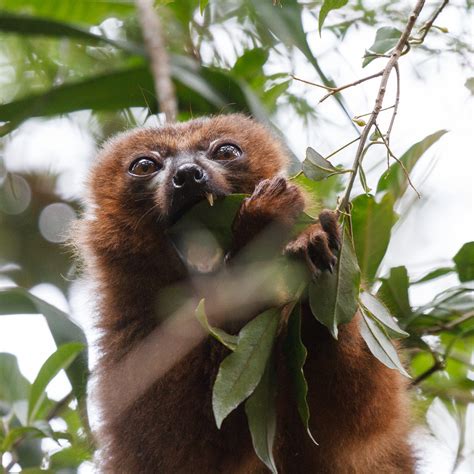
(309, 222, 360, 339)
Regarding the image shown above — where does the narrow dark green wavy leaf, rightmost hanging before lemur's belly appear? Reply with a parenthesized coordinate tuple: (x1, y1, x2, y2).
(284, 303, 318, 445)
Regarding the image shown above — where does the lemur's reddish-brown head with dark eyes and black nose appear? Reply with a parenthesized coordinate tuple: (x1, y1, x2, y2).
(91, 115, 286, 227)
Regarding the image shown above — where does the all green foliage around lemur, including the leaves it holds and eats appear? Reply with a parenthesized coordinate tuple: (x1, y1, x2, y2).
(0, 0, 474, 472)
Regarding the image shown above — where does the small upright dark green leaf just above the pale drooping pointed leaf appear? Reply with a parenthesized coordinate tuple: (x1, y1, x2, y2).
(377, 266, 412, 319)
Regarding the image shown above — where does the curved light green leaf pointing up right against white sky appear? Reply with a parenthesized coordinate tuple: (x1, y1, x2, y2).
(377, 130, 447, 200)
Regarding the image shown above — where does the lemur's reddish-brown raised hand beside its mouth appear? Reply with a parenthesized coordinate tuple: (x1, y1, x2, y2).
(229, 177, 304, 256)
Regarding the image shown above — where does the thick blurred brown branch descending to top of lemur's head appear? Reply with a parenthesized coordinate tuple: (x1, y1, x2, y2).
(135, 0, 178, 122)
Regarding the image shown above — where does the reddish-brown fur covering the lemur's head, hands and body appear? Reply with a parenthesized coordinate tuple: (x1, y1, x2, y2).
(78, 115, 413, 474)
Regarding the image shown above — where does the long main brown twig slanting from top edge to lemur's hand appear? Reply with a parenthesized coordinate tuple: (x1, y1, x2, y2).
(338, 0, 425, 212)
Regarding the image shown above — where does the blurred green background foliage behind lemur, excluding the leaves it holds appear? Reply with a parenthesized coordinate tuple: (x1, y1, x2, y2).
(0, 0, 474, 473)
